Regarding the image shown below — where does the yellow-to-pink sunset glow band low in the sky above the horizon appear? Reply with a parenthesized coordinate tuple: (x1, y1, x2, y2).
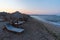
(0, 8, 58, 14)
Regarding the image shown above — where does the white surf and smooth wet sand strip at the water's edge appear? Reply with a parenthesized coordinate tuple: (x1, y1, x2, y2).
(31, 16, 60, 34)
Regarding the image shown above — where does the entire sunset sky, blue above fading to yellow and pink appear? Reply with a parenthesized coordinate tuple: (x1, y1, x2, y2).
(0, 0, 60, 14)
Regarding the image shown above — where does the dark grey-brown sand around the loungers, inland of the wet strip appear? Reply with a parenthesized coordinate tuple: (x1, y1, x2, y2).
(0, 18, 56, 40)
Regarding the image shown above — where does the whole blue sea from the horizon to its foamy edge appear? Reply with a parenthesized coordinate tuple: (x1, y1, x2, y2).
(31, 15, 60, 26)
